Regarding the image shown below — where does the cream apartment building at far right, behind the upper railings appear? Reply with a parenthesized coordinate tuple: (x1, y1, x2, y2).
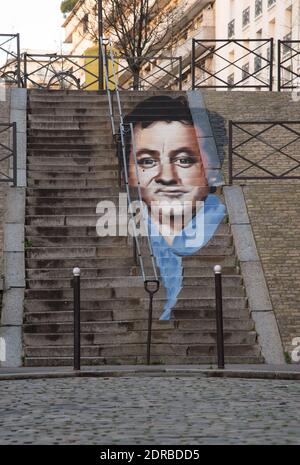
(214, 0, 300, 90)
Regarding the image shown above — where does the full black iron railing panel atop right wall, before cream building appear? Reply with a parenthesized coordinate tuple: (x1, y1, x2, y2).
(192, 39, 274, 91)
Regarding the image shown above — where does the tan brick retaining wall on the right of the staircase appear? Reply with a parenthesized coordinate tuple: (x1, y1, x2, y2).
(204, 91, 300, 351)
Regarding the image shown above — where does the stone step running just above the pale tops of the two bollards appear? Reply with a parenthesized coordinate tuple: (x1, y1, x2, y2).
(26, 252, 237, 270)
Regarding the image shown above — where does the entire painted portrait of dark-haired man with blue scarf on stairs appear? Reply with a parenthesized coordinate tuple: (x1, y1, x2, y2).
(124, 92, 226, 320)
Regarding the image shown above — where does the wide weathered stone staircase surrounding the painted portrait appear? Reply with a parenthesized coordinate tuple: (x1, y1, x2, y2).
(23, 91, 263, 366)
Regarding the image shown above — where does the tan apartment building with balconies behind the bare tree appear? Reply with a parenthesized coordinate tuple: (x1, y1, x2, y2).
(63, 0, 215, 90)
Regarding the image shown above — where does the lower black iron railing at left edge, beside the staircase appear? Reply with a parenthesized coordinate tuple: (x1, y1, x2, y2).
(0, 123, 17, 187)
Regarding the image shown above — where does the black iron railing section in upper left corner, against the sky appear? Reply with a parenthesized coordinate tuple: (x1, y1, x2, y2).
(0, 34, 22, 87)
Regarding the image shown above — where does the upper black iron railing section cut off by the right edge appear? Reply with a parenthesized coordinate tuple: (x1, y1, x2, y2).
(277, 40, 300, 92)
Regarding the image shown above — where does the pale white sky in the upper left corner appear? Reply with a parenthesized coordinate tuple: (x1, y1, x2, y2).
(0, 0, 64, 51)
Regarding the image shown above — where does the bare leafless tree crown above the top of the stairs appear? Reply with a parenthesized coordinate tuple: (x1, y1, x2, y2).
(70, 0, 185, 85)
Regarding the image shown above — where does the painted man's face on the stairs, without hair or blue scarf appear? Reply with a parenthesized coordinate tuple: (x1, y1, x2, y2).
(129, 121, 208, 221)
